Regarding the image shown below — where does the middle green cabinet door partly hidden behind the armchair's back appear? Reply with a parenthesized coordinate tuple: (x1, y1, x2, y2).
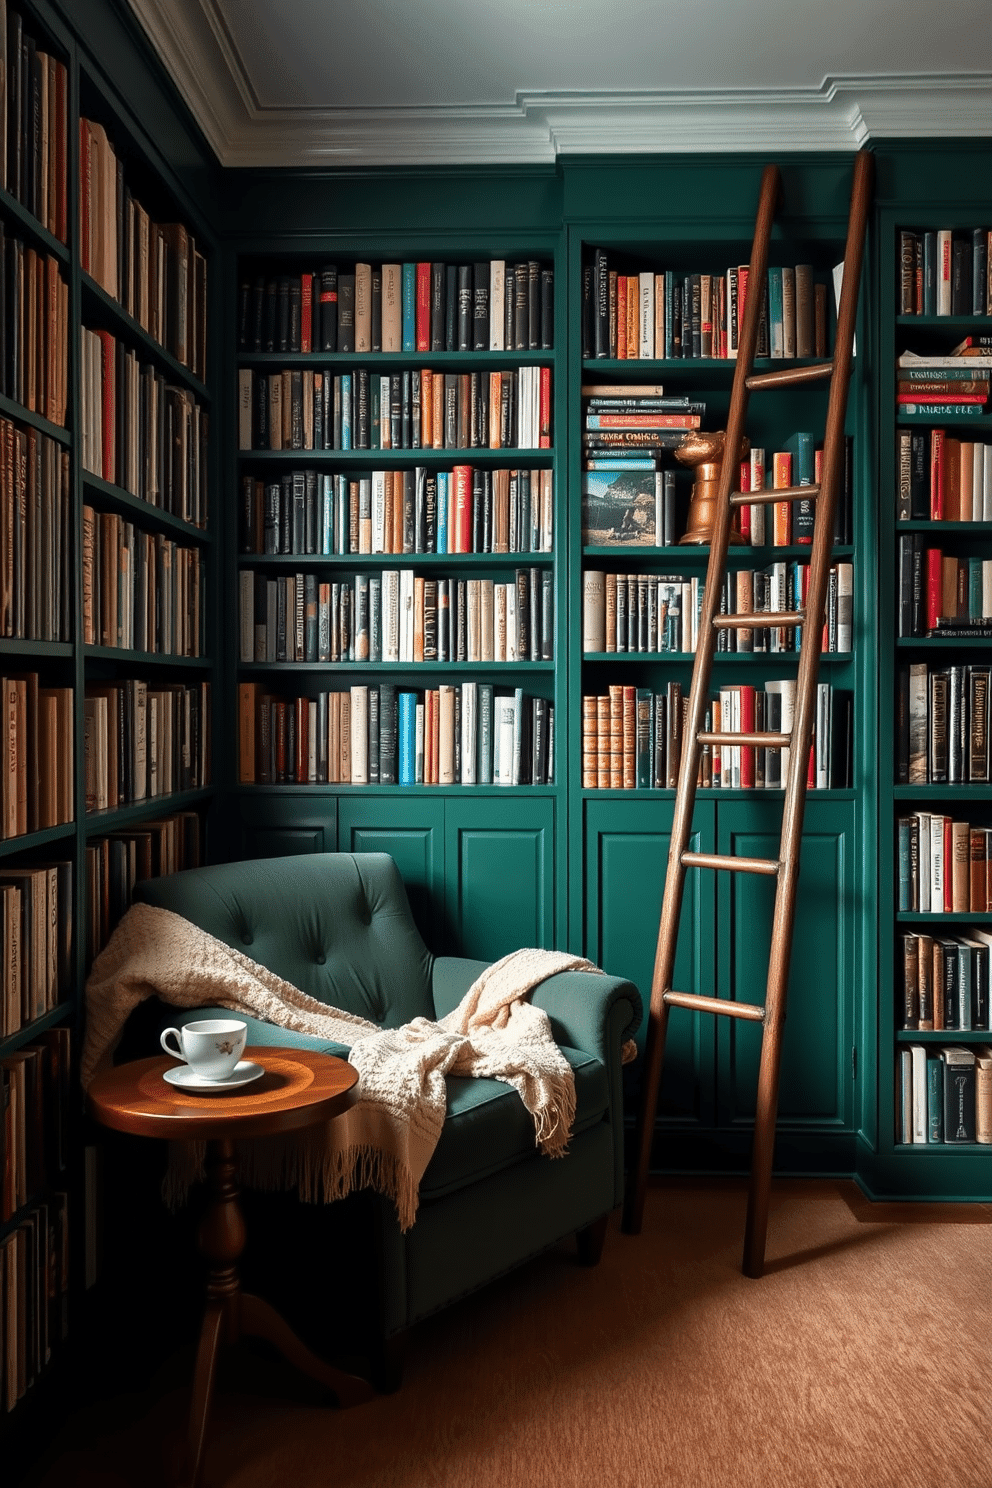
(338, 795, 445, 951)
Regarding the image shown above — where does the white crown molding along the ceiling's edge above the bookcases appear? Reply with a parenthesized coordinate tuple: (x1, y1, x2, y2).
(121, 0, 992, 167)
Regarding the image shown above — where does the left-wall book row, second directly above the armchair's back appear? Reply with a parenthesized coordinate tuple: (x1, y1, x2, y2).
(83, 679, 210, 812)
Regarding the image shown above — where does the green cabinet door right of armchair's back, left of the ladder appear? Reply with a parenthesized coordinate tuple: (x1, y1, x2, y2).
(445, 796, 555, 961)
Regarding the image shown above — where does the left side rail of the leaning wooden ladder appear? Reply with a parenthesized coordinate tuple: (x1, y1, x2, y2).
(623, 165, 781, 1234)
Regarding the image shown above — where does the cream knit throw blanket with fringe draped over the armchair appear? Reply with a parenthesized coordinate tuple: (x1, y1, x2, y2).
(82, 905, 599, 1229)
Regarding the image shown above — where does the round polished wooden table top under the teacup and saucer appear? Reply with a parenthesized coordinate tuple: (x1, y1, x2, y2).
(88, 1046, 358, 1141)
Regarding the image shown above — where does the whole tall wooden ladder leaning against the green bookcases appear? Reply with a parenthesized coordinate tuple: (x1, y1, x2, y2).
(623, 152, 873, 1277)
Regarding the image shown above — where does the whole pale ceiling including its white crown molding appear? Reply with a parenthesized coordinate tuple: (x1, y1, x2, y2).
(129, 0, 992, 165)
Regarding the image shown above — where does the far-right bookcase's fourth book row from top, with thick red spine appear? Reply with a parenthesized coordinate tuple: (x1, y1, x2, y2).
(897, 547, 992, 638)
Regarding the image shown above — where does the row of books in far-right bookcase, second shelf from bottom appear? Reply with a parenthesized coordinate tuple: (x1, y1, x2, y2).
(901, 926, 992, 1033)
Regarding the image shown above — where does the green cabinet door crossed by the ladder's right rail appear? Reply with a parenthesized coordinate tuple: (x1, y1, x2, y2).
(717, 799, 855, 1129)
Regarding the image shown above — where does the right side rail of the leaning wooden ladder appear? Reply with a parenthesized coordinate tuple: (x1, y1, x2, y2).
(744, 152, 873, 1277)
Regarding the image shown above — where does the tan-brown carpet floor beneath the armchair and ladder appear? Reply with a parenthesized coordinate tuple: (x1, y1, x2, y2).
(29, 1183, 992, 1488)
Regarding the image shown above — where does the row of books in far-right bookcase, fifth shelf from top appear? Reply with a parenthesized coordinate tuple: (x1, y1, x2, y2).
(895, 661, 992, 786)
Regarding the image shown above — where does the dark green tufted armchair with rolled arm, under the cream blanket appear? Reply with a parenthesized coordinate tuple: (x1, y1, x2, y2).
(131, 853, 641, 1386)
